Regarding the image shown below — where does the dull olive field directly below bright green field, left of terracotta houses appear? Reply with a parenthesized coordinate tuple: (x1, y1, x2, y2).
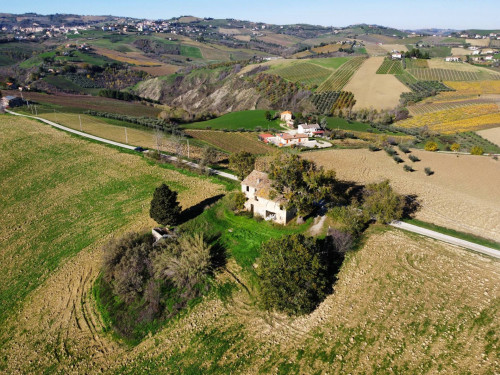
(186, 130, 273, 154)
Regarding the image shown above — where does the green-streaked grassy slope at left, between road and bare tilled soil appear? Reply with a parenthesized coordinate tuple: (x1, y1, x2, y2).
(0, 116, 227, 328)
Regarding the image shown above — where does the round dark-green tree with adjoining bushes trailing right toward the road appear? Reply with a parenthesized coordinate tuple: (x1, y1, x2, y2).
(256, 177, 405, 315)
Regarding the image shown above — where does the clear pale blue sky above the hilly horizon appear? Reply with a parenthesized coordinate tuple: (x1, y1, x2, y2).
(0, 0, 500, 29)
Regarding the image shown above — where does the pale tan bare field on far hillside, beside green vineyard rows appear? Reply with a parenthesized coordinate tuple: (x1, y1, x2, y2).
(344, 57, 409, 109)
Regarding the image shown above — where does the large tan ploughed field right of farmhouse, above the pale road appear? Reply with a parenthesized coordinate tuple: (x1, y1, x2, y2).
(304, 149, 500, 242)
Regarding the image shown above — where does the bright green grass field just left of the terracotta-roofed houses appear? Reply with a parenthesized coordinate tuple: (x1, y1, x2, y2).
(182, 110, 279, 130)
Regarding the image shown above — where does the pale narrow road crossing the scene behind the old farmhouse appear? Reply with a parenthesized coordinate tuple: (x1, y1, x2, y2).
(5, 109, 500, 259)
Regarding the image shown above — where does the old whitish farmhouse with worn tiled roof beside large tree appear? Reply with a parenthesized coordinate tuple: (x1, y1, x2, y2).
(241, 170, 295, 224)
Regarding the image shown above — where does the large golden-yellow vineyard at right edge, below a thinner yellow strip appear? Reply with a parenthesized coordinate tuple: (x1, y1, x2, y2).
(398, 103, 500, 133)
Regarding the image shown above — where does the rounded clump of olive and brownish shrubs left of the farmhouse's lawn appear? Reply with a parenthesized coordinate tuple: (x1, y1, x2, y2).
(99, 233, 212, 340)
